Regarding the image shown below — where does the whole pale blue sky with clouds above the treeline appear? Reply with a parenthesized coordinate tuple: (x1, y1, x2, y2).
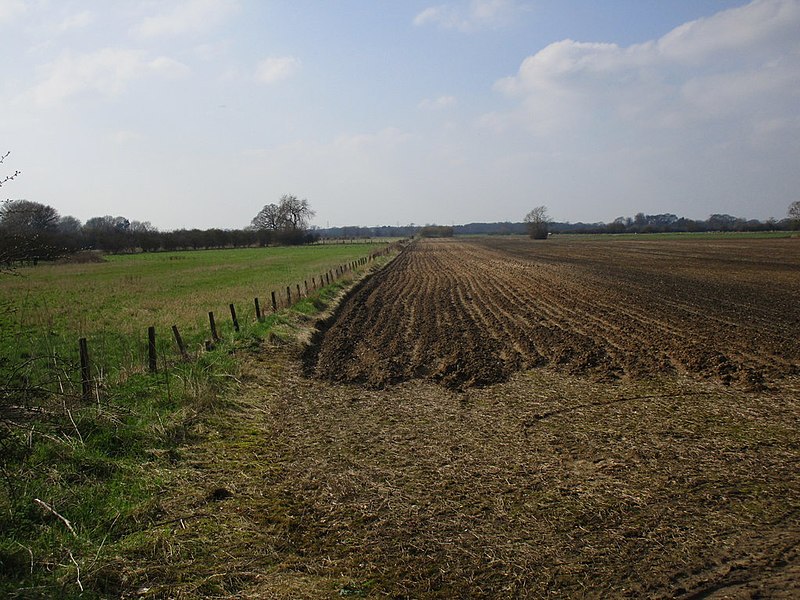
(0, 0, 800, 230)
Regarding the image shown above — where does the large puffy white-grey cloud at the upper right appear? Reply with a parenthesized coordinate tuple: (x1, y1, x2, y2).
(484, 0, 800, 135)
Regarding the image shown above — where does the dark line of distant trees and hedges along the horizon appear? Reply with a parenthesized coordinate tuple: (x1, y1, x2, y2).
(0, 200, 800, 263)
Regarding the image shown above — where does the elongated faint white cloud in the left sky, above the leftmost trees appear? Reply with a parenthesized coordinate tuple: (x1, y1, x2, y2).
(32, 48, 188, 106)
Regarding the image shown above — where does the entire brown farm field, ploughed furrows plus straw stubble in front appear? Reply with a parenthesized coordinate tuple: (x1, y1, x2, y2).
(120, 238, 800, 599)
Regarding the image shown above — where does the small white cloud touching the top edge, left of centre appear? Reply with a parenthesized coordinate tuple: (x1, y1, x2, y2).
(134, 0, 239, 37)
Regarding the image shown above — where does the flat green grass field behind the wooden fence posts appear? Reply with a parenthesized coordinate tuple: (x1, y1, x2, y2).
(0, 243, 384, 380)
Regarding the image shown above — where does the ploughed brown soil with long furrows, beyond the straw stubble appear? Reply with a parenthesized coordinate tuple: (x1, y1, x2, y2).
(309, 237, 800, 389)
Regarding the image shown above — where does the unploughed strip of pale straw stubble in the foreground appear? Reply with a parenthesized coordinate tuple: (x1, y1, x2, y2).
(117, 346, 800, 598)
